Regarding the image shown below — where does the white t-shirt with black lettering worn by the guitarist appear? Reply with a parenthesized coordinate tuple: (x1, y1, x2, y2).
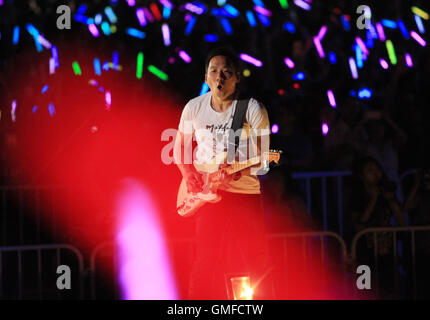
(179, 92, 270, 194)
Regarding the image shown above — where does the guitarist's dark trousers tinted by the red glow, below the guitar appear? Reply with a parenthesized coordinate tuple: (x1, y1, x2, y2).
(189, 192, 271, 299)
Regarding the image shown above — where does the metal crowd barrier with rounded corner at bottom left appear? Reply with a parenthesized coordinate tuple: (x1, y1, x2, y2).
(0, 244, 84, 300)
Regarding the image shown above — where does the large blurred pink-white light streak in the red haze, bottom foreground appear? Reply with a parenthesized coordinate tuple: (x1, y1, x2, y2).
(116, 179, 178, 300)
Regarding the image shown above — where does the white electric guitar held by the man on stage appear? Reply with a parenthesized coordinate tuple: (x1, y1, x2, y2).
(177, 150, 282, 217)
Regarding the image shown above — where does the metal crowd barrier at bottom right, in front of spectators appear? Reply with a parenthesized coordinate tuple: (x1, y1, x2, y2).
(351, 226, 430, 299)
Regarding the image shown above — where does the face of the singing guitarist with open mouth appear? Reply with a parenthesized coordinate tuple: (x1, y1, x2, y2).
(205, 56, 240, 100)
